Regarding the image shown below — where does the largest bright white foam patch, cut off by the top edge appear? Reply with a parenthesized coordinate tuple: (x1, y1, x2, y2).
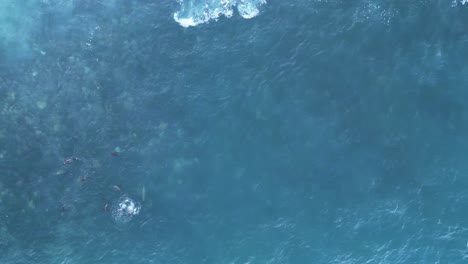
(174, 0, 266, 27)
